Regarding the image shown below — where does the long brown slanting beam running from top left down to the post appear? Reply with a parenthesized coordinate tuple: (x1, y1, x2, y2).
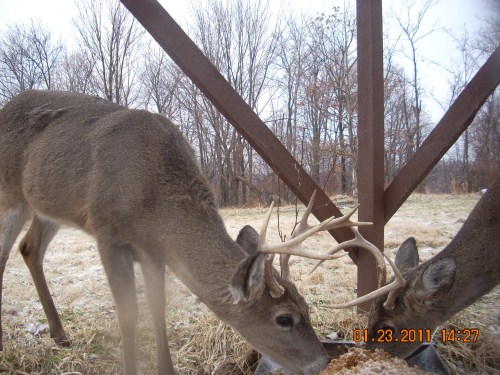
(121, 0, 355, 245)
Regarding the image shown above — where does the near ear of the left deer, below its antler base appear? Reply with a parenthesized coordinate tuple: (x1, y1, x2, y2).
(229, 252, 266, 304)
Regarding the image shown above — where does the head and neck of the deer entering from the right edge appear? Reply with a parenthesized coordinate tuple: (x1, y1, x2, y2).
(368, 176, 500, 358)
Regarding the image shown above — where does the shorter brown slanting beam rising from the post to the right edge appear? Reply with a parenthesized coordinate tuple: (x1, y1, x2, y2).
(384, 47, 500, 223)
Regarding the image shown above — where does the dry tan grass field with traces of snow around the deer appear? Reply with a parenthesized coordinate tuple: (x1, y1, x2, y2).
(0, 194, 500, 375)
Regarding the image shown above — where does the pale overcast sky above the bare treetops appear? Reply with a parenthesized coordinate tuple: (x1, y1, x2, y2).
(0, 0, 500, 119)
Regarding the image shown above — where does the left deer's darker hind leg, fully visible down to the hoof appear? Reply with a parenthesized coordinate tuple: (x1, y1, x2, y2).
(19, 215, 70, 346)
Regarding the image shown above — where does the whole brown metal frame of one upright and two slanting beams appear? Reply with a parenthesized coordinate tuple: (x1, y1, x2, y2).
(121, 0, 500, 311)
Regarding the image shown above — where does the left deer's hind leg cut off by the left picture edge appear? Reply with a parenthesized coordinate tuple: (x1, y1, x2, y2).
(0, 205, 31, 350)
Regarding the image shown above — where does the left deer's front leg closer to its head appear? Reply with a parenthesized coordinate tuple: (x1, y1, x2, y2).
(141, 262, 175, 375)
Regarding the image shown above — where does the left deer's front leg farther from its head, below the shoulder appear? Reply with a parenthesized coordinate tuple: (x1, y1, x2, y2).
(98, 241, 138, 375)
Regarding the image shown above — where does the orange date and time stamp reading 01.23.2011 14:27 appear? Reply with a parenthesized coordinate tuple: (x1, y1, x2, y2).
(353, 328, 479, 344)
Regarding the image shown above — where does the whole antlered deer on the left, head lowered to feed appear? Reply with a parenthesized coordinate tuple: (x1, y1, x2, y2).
(0, 90, 402, 375)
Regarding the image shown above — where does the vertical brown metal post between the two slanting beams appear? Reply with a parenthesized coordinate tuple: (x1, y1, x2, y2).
(356, 0, 384, 312)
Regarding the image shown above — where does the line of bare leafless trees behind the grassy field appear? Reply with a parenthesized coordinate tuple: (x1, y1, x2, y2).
(0, 0, 500, 206)
